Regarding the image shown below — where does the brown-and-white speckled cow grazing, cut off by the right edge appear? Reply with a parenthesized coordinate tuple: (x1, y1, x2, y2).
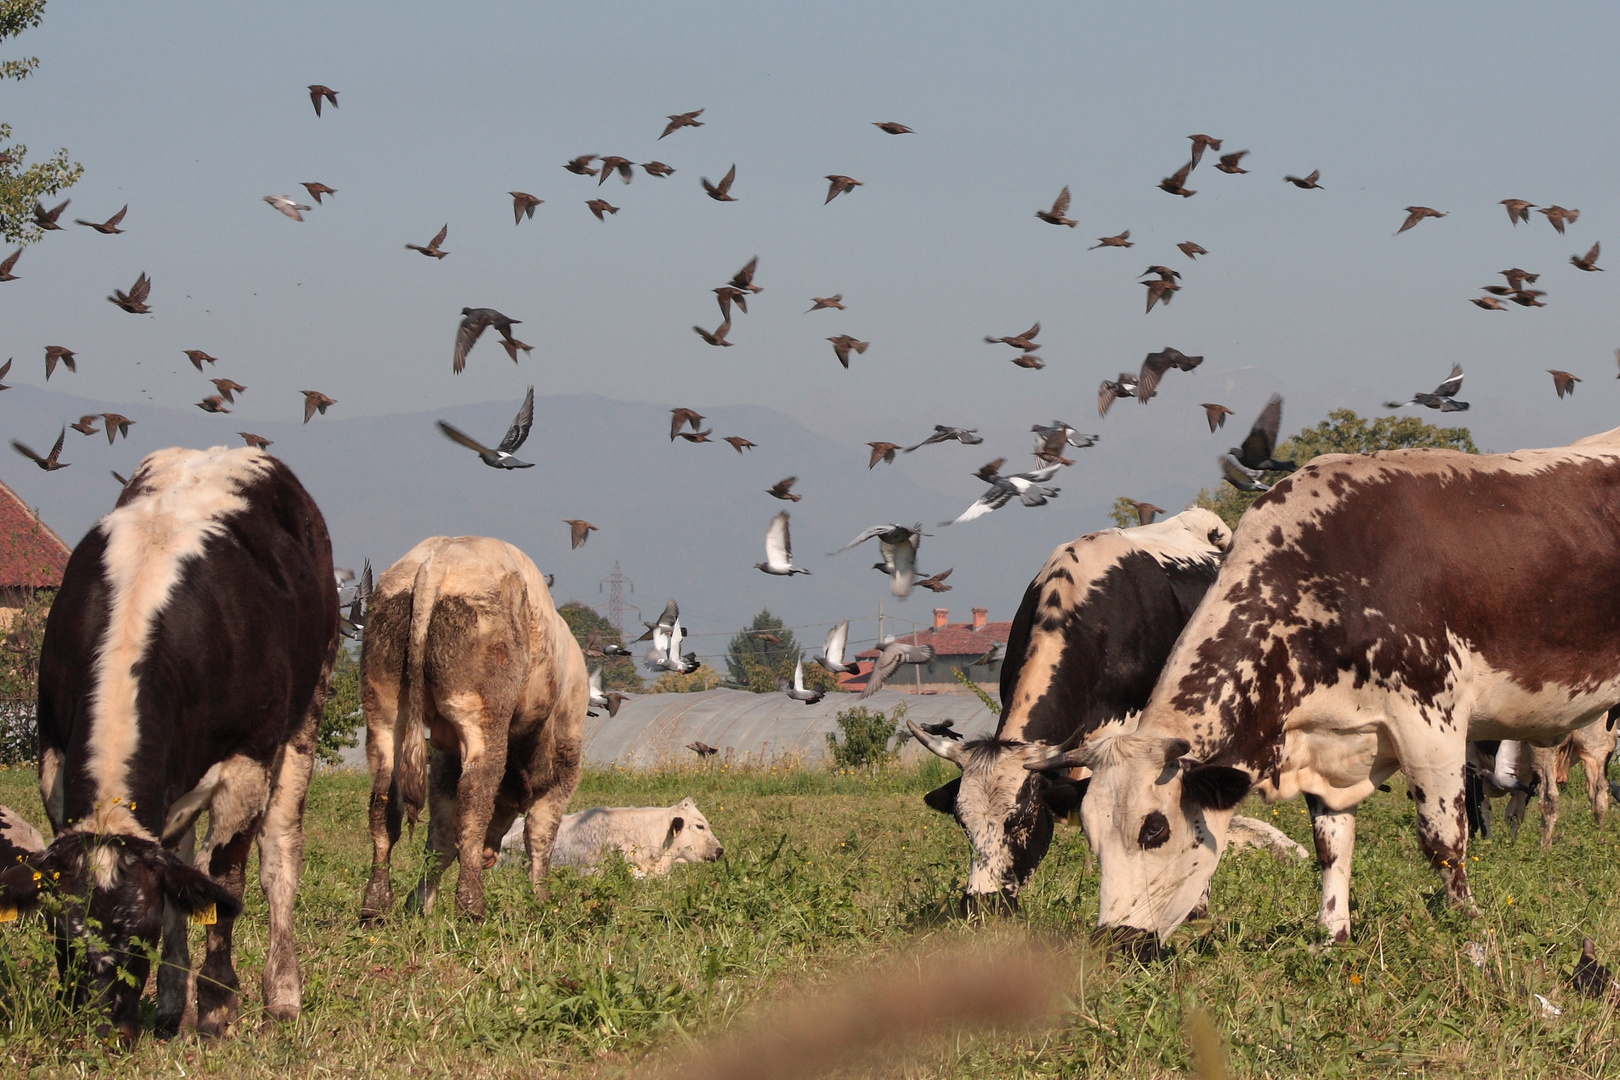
(1050, 429, 1620, 941)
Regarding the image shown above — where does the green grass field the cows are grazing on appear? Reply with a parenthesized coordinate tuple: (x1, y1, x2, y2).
(0, 761, 1620, 1080)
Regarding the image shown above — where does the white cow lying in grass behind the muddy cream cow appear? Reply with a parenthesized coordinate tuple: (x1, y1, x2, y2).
(501, 797, 726, 878)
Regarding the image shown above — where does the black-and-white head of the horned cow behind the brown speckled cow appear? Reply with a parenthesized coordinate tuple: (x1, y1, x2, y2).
(907, 721, 1087, 915)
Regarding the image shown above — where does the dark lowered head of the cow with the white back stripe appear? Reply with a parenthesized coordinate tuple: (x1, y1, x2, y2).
(0, 832, 241, 1043)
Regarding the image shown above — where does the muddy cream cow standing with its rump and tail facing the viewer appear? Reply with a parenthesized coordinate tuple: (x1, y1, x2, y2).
(360, 536, 590, 921)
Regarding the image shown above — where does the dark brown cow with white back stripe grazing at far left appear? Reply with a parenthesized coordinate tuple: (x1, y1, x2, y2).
(0, 447, 337, 1041)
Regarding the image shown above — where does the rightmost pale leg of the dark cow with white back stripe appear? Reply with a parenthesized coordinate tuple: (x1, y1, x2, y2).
(259, 712, 315, 1020)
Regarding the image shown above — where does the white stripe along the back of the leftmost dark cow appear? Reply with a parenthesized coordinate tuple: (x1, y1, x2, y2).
(76, 447, 272, 839)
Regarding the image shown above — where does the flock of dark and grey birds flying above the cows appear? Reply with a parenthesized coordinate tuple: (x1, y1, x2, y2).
(0, 95, 1620, 709)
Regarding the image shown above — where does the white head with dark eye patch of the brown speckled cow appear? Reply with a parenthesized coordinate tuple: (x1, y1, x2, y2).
(1029, 733, 1252, 942)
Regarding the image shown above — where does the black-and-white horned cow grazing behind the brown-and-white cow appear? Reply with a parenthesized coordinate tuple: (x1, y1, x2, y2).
(910, 508, 1231, 912)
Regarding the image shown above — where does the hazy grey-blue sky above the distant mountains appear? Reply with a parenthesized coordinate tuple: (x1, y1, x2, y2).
(0, 0, 1620, 660)
